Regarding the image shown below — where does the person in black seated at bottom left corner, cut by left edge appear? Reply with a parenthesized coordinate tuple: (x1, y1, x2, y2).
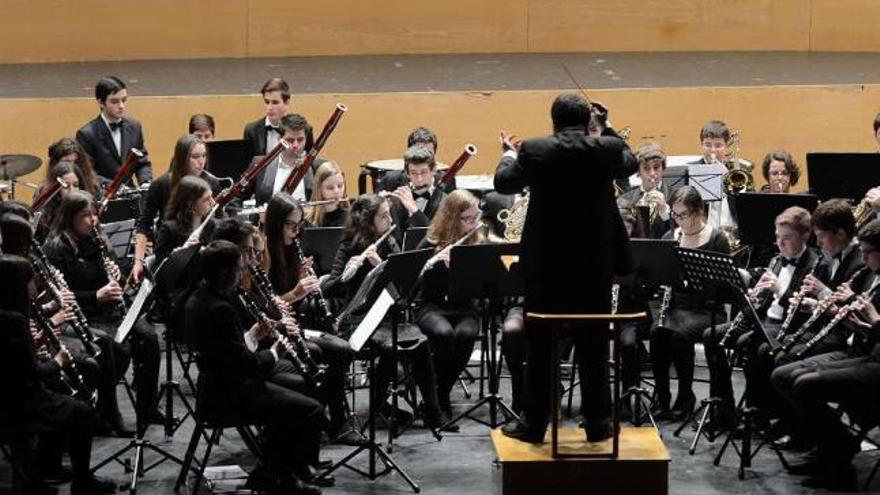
(0, 256, 116, 495)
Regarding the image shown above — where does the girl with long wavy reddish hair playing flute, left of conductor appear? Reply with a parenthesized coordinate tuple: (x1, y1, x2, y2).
(415, 190, 485, 418)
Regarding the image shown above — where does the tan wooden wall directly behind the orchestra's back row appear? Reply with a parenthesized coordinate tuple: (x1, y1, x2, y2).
(0, 85, 880, 201)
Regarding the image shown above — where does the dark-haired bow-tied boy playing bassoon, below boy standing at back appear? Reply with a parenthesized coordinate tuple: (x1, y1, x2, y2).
(244, 114, 324, 205)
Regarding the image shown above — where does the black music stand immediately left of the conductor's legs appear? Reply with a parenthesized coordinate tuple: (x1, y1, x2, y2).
(440, 243, 525, 430)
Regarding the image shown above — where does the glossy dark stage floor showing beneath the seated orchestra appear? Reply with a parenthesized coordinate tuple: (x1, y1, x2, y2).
(0, 342, 880, 495)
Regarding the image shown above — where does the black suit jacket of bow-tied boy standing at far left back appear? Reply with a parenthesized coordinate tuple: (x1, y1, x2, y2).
(76, 115, 153, 184)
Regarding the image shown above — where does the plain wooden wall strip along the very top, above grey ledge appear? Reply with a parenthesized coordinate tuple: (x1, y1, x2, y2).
(0, 0, 880, 63)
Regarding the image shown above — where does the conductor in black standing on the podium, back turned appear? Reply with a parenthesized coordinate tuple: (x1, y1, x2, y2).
(495, 94, 637, 443)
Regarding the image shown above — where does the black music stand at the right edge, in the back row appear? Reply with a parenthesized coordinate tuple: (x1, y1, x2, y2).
(807, 153, 880, 201)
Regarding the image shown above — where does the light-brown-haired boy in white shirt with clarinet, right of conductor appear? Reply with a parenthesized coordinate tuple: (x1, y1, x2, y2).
(703, 206, 819, 429)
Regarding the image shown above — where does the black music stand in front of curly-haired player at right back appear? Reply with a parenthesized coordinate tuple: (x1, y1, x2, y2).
(734, 192, 819, 245)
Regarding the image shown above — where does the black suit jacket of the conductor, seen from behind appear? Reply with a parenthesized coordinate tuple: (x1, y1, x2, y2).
(495, 128, 638, 312)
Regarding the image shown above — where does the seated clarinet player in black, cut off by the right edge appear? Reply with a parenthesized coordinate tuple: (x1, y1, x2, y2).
(772, 220, 880, 490)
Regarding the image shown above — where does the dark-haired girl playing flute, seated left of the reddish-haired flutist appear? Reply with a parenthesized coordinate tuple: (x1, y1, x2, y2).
(325, 194, 457, 431)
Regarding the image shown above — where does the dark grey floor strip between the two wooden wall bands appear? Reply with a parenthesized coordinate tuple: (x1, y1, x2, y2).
(0, 52, 880, 98)
